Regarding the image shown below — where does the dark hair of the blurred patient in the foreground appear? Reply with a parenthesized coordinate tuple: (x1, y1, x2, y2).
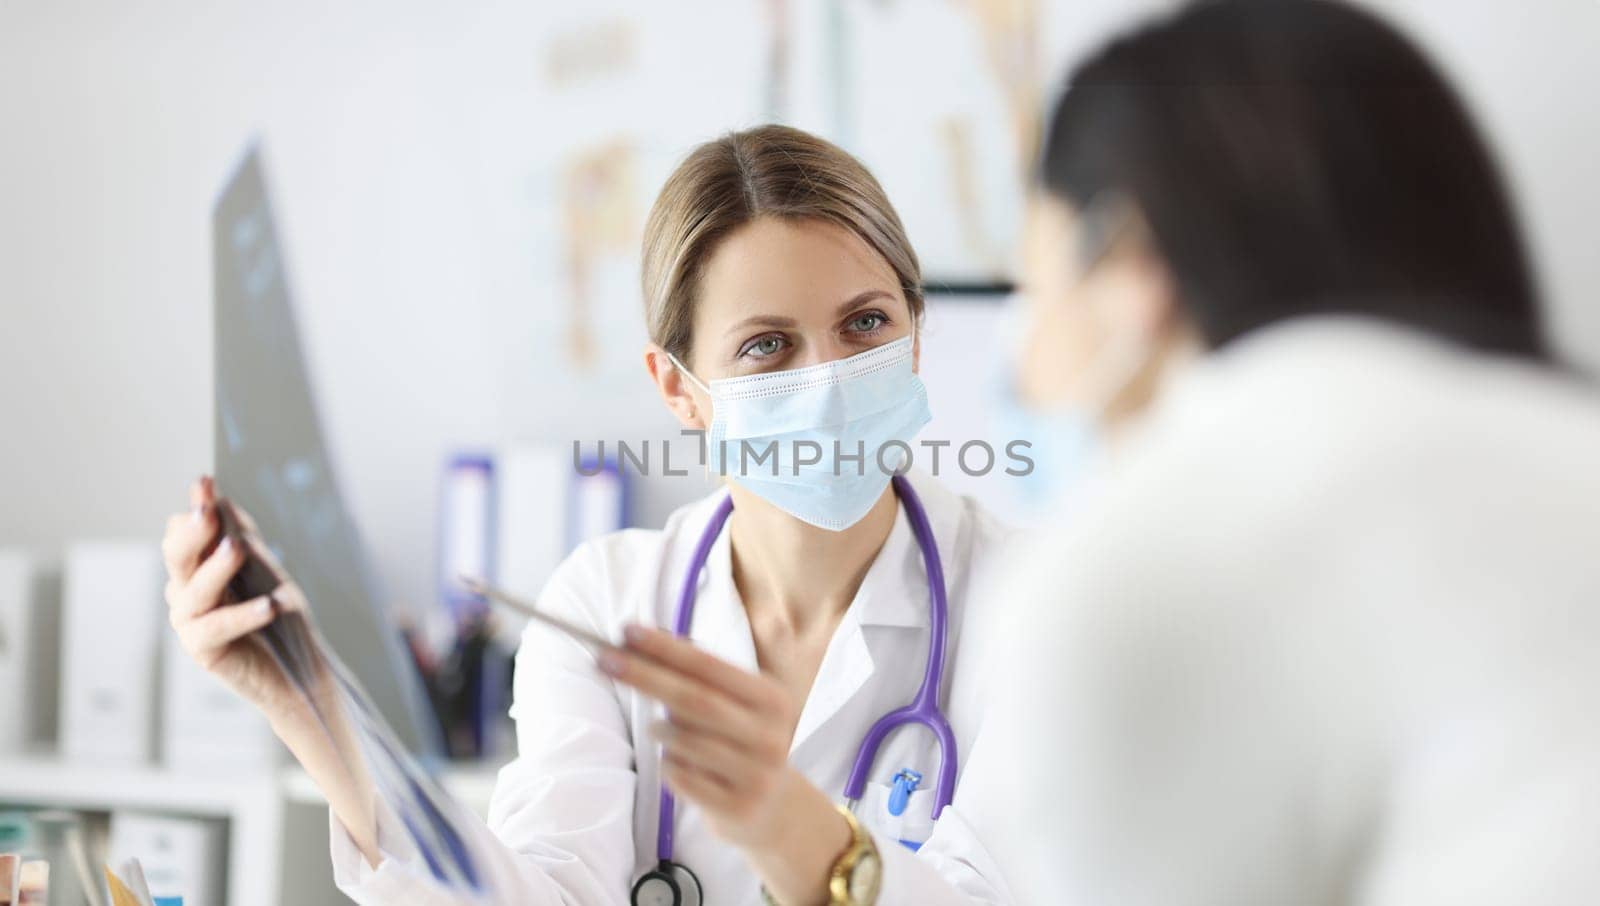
(1040, 0, 1546, 359)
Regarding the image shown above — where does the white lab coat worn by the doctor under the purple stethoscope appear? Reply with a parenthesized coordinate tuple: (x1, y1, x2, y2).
(331, 474, 1010, 906)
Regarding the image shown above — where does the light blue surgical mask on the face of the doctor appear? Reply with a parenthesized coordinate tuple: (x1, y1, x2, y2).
(669, 336, 931, 531)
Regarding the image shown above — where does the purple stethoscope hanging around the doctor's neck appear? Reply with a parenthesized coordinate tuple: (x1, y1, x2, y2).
(632, 475, 955, 906)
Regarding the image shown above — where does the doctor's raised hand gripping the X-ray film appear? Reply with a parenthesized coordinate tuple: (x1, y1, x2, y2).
(162, 479, 296, 716)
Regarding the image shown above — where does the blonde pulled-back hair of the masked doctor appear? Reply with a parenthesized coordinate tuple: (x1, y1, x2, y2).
(643, 125, 923, 360)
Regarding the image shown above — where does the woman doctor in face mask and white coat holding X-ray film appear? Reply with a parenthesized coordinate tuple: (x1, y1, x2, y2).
(165, 126, 1003, 906)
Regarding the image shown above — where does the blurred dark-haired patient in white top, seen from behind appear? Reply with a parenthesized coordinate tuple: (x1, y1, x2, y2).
(957, 0, 1600, 906)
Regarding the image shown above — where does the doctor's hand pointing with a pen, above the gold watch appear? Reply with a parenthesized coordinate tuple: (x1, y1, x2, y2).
(600, 626, 851, 903)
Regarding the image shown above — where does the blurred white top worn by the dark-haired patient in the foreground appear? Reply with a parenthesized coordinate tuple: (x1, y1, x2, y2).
(957, 319, 1600, 906)
